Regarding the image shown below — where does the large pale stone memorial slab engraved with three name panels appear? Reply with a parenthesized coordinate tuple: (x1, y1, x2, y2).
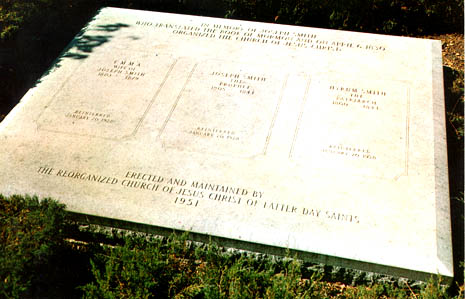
(0, 8, 453, 279)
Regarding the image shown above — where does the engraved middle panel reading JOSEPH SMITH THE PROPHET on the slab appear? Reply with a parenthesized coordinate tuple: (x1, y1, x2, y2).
(160, 60, 285, 157)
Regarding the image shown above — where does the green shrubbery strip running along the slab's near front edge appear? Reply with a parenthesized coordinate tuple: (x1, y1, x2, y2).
(0, 196, 463, 299)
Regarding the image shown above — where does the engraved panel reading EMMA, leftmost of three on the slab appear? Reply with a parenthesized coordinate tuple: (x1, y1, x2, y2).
(38, 51, 175, 139)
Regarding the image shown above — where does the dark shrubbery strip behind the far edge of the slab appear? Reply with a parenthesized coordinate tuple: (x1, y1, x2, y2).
(0, 0, 464, 41)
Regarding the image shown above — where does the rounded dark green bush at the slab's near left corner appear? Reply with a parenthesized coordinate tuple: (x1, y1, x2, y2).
(0, 195, 65, 298)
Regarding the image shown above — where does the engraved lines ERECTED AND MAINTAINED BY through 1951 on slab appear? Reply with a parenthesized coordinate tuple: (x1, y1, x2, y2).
(36, 165, 361, 225)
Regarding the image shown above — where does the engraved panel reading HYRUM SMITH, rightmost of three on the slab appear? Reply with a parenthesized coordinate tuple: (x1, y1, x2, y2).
(290, 79, 409, 179)
